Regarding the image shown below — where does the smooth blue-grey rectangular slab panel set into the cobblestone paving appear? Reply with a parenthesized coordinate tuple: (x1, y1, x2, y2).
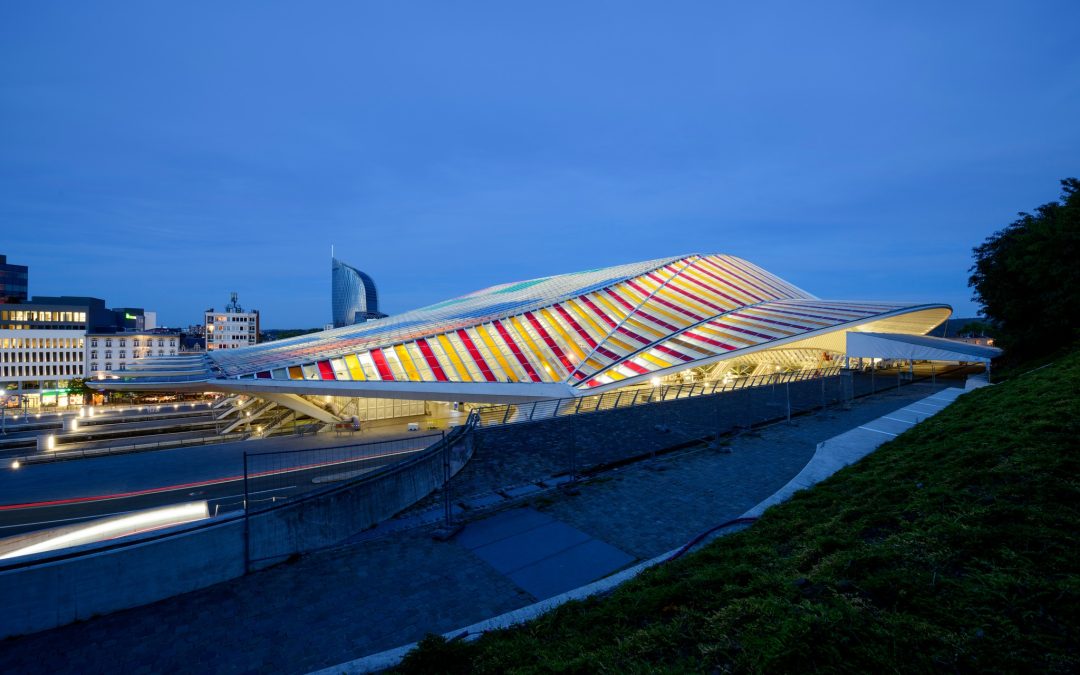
(456, 509, 635, 599)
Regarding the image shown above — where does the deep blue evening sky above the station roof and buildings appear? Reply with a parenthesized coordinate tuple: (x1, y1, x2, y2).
(0, 0, 1080, 327)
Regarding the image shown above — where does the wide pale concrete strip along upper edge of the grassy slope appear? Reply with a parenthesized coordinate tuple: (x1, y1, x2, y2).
(743, 388, 966, 517)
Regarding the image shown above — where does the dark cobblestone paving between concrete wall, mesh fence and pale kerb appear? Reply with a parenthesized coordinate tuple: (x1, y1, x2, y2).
(0, 384, 954, 673)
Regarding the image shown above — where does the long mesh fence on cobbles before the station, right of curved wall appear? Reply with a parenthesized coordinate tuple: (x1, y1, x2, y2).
(438, 366, 963, 510)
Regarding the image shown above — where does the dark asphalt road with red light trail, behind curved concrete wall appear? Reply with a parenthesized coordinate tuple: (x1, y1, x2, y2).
(0, 431, 435, 537)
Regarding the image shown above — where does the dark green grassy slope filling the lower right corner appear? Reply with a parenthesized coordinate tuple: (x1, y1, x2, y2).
(401, 353, 1080, 673)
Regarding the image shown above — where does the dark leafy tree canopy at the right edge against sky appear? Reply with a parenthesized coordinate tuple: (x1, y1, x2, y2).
(968, 178, 1080, 355)
